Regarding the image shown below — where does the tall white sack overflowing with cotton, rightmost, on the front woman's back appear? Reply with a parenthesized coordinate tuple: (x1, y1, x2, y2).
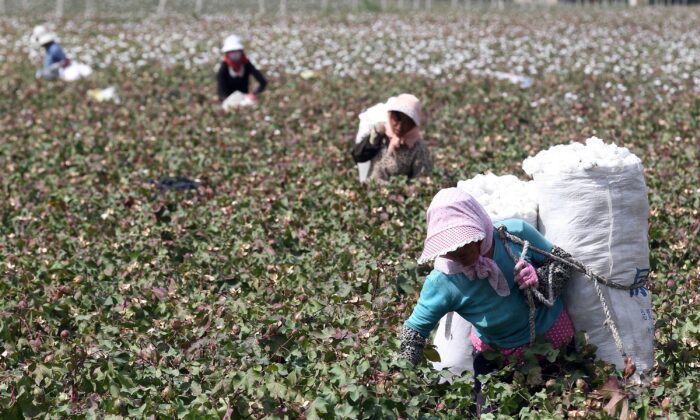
(523, 138, 654, 378)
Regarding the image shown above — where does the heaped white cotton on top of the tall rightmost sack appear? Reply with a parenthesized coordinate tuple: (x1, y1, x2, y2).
(523, 137, 641, 177)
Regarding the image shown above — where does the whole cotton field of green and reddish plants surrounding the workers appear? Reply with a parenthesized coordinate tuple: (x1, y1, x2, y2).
(0, 4, 700, 418)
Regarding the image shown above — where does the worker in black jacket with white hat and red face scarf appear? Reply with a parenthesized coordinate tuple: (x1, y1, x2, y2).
(216, 35, 267, 102)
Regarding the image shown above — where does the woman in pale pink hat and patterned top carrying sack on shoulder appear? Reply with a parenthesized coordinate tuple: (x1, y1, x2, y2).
(352, 93, 432, 183)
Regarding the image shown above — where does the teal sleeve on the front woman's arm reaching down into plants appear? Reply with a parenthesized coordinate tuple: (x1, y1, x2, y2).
(405, 271, 453, 338)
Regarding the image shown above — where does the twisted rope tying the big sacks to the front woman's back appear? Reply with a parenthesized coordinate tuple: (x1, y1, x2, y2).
(498, 226, 628, 362)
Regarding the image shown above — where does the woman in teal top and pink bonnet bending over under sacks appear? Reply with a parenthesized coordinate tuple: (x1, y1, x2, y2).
(401, 188, 574, 411)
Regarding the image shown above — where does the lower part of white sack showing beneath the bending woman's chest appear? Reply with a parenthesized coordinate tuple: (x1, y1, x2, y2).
(432, 312, 474, 382)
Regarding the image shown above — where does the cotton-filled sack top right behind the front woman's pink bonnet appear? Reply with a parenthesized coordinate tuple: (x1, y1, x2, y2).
(457, 174, 537, 227)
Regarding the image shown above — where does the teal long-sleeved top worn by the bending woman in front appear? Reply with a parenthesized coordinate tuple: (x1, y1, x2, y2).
(405, 219, 563, 348)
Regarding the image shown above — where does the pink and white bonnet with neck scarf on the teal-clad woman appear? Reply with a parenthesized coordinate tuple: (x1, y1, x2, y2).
(418, 188, 510, 296)
